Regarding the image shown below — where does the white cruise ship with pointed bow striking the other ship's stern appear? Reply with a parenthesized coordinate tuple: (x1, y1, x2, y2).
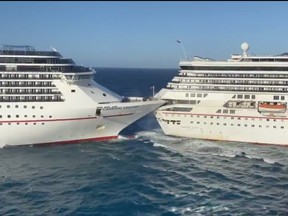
(0, 45, 163, 147)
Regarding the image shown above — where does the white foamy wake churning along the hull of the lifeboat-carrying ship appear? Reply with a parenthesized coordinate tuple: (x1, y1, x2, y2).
(137, 129, 288, 165)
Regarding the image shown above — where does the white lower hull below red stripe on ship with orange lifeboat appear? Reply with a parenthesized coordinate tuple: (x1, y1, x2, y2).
(156, 107, 288, 145)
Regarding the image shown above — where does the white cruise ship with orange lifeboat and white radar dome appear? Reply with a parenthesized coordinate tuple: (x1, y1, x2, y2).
(155, 42, 288, 145)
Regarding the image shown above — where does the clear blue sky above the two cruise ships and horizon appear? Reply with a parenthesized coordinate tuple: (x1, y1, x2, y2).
(0, 1, 288, 68)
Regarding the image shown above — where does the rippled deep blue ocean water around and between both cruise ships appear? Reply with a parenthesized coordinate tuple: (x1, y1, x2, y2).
(0, 68, 288, 216)
